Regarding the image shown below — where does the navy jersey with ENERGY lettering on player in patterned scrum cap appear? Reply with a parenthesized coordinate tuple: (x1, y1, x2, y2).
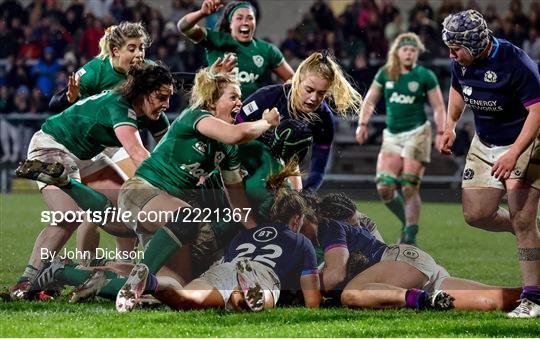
(452, 37, 540, 146)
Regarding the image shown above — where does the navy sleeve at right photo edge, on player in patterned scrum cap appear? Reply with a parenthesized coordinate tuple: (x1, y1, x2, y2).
(511, 49, 540, 107)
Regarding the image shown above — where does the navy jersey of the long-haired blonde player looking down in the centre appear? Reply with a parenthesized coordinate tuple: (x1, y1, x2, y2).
(236, 84, 335, 147)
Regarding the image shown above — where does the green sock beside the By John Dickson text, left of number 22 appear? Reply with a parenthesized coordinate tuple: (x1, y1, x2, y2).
(141, 228, 182, 273)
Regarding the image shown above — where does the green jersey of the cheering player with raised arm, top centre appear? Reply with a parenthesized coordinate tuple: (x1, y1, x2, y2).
(202, 30, 285, 100)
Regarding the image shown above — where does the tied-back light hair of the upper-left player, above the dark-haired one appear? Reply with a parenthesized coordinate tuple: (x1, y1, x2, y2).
(97, 21, 152, 59)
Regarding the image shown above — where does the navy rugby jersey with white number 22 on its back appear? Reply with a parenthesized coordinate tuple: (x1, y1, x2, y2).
(225, 223, 318, 288)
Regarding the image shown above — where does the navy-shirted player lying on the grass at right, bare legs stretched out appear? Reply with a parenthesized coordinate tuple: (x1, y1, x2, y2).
(302, 196, 520, 311)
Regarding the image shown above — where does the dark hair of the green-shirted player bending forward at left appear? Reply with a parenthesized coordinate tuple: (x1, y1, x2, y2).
(116, 63, 175, 103)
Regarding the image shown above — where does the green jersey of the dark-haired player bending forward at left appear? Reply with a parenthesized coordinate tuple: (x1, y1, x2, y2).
(41, 92, 138, 160)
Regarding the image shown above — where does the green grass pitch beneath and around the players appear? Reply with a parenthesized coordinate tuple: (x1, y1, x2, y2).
(0, 194, 540, 337)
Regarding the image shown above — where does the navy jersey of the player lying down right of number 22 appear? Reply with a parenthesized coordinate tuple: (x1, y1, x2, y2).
(317, 219, 388, 268)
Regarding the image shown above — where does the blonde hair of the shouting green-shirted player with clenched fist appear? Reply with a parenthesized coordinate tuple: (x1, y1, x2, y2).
(189, 68, 240, 110)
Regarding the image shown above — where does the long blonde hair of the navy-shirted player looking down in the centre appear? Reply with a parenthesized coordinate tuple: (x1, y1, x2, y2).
(288, 52, 362, 120)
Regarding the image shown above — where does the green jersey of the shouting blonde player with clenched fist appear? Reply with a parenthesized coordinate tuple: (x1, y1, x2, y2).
(135, 108, 240, 199)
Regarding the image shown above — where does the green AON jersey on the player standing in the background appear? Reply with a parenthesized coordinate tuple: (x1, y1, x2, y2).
(374, 65, 439, 133)
